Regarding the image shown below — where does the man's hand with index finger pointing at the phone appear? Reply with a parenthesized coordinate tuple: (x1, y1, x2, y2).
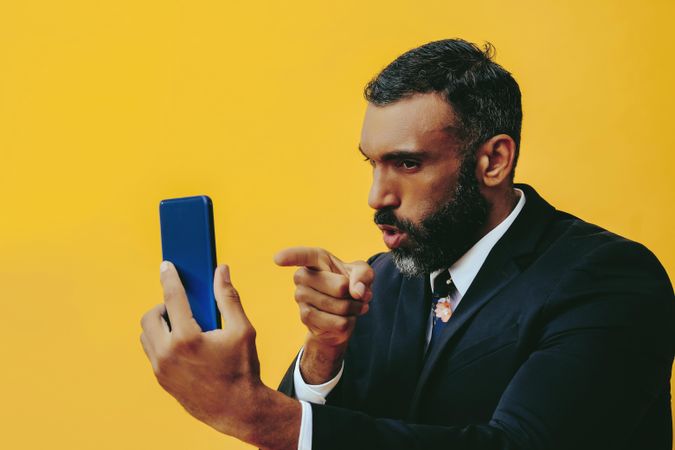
(274, 247, 375, 384)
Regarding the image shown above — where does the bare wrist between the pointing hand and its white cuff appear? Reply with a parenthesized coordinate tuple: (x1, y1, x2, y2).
(300, 338, 347, 384)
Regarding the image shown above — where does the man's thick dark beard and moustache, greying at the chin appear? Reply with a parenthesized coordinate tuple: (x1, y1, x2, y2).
(375, 153, 490, 277)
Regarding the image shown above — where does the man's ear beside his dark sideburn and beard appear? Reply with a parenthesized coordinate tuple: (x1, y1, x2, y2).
(476, 134, 516, 187)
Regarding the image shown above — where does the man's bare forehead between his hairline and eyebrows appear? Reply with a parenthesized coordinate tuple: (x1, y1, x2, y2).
(360, 93, 462, 153)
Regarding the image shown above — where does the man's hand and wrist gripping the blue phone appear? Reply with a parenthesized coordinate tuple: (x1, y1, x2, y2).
(141, 261, 301, 449)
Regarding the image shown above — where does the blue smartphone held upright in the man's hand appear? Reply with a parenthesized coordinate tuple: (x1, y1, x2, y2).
(159, 195, 221, 331)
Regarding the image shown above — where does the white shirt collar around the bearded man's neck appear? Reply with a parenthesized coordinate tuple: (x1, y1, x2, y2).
(430, 188, 525, 297)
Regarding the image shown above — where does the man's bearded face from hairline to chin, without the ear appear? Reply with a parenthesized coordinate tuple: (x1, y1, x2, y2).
(360, 93, 489, 276)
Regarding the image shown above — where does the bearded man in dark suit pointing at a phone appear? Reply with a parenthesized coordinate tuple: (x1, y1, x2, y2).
(141, 40, 675, 450)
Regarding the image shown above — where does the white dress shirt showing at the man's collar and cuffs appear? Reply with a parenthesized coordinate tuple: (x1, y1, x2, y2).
(293, 188, 525, 450)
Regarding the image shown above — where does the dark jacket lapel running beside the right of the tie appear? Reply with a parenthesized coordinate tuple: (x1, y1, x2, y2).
(410, 185, 554, 416)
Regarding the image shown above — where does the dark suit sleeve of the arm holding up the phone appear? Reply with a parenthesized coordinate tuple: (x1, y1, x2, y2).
(312, 241, 675, 450)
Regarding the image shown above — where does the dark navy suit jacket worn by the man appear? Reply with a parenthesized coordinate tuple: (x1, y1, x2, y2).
(280, 185, 675, 450)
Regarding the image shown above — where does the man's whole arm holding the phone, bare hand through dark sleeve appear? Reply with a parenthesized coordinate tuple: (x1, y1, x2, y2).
(141, 246, 675, 450)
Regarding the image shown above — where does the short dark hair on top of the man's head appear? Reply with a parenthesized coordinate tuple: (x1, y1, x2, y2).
(364, 39, 523, 179)
